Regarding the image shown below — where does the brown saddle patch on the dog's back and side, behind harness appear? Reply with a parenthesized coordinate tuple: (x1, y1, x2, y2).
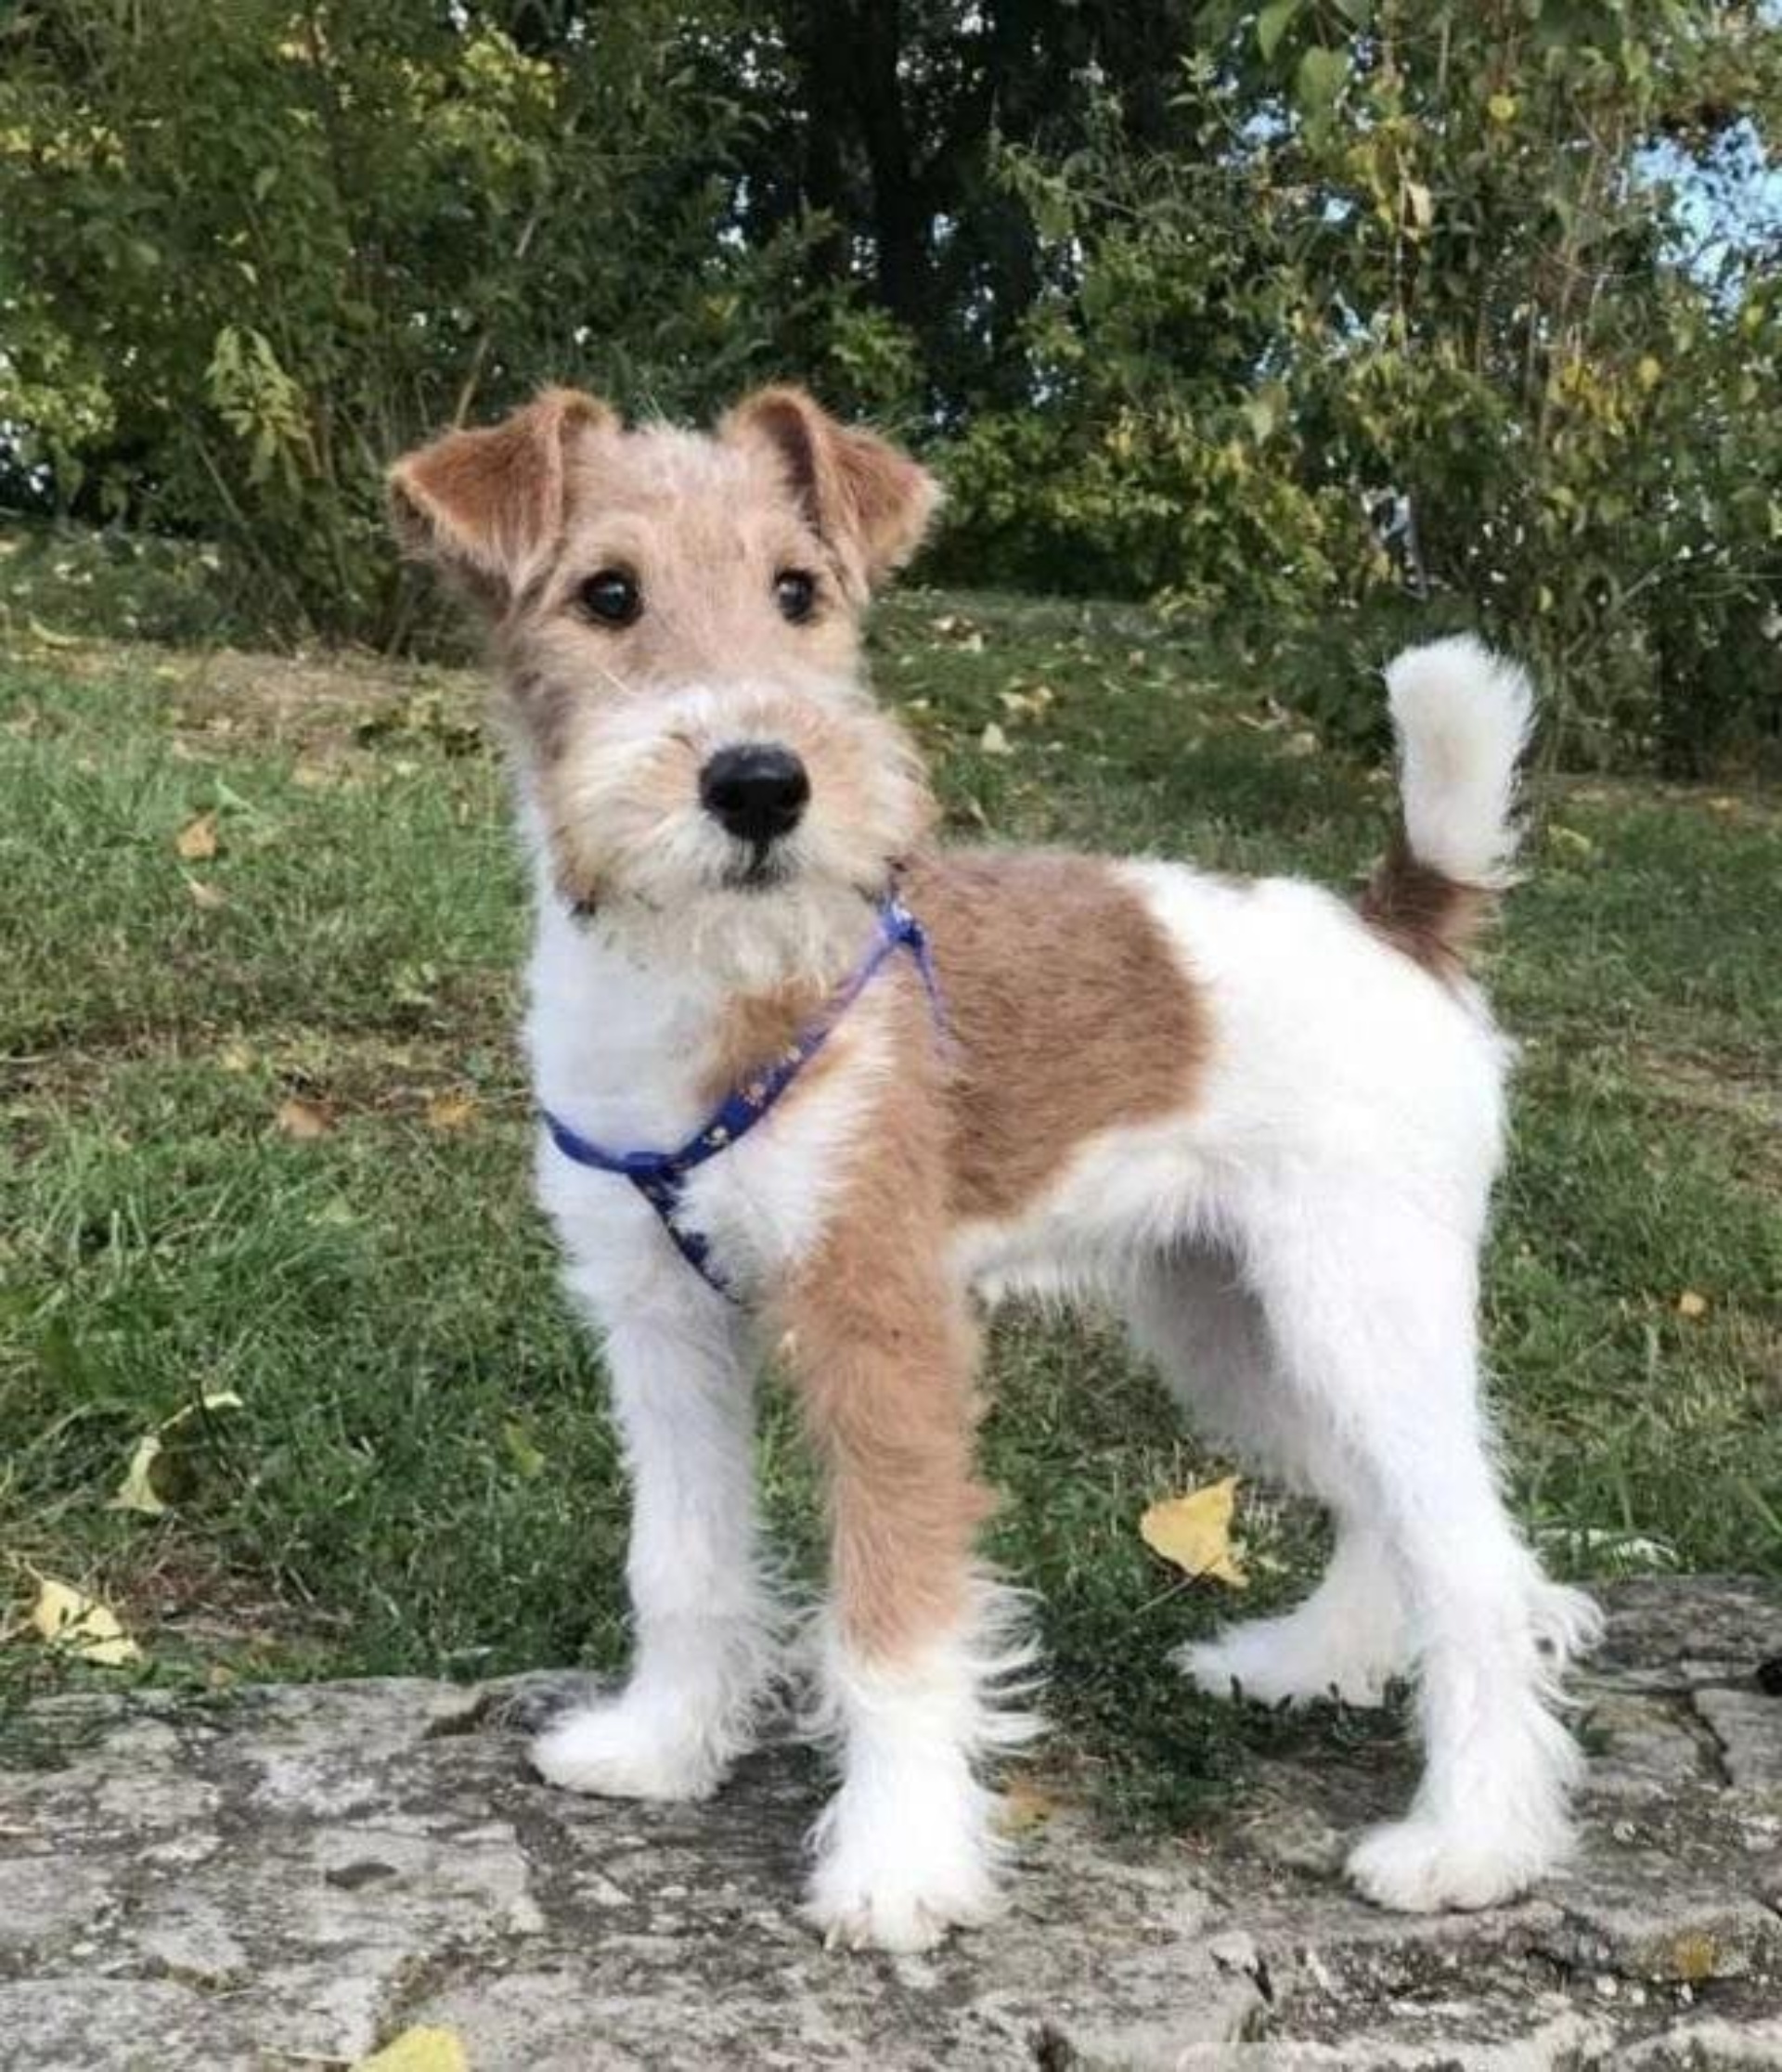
(906, 850, 1208, 1218)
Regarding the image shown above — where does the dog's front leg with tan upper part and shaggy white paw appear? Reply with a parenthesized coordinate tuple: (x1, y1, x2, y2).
(787, 1225, 1022, 1950)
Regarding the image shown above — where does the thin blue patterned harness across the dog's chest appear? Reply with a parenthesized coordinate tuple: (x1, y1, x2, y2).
(541, 895, 947, 1301)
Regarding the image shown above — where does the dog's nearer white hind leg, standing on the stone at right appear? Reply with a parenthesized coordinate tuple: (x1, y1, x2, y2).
(1244, 1179, 1595, 1911)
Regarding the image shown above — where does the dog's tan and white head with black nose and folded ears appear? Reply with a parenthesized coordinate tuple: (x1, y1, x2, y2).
(390, 388, 936, 955)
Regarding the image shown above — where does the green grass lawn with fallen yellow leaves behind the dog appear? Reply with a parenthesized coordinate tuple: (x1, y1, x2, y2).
(0, 595, 1782, 1817)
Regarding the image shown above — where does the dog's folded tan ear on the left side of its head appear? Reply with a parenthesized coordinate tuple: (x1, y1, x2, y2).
(390, 390, 617, 611)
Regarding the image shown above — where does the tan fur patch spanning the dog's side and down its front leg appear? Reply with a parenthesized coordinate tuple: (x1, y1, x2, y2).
(754, 852, 1208, 1655)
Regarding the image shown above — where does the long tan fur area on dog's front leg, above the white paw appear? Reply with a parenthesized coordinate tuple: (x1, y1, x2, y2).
(779, 972, 990, 1660)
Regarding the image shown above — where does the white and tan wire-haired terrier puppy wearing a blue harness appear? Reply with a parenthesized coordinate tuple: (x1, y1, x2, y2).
(390, 388, 1597, 1950)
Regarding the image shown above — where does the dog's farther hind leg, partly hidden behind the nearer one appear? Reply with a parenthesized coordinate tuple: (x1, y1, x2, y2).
(1128, 1252, 1411, 1705)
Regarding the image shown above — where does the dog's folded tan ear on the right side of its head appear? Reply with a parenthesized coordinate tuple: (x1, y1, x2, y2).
(719, 388, 941, 588)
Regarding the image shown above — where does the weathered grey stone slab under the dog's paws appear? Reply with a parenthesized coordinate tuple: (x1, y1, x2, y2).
(0, 1579, 1782, 2072)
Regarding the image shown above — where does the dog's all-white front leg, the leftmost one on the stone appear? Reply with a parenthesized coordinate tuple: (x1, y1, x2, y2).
(533, 1262, 775, 1798)
